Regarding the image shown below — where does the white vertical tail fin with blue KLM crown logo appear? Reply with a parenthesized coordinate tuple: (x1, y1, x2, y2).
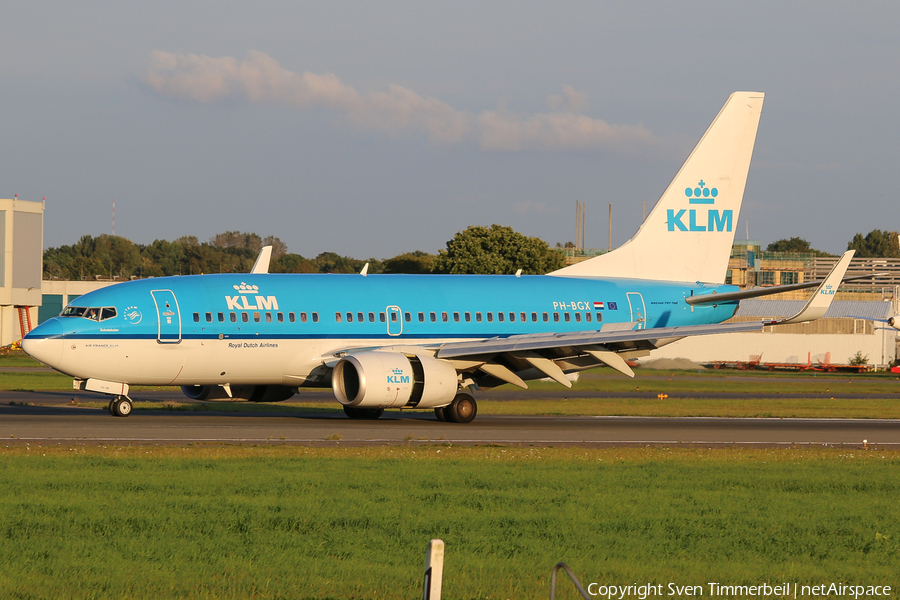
(550, 92, 764, 284)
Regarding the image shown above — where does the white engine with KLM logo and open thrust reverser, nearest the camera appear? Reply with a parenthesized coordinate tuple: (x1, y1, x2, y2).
(331, 351, 459, 408)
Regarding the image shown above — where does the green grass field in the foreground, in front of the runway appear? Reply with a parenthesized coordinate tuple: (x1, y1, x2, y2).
(0, 446, 900, 599)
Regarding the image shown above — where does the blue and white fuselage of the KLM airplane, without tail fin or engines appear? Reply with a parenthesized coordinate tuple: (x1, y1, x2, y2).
(22, 274, 736, 387)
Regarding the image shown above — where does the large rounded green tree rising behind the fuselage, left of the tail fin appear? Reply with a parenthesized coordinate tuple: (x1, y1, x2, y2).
(433, 224, 566, 275)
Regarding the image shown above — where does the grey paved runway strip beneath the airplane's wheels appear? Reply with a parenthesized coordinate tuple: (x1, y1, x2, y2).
(0, 392, 900, 448)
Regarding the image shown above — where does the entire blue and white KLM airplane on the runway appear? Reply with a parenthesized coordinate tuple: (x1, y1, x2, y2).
(22, 92, 852, 423)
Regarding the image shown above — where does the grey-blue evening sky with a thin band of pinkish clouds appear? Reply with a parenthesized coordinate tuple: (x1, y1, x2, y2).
(0, 0, 900, 258)
